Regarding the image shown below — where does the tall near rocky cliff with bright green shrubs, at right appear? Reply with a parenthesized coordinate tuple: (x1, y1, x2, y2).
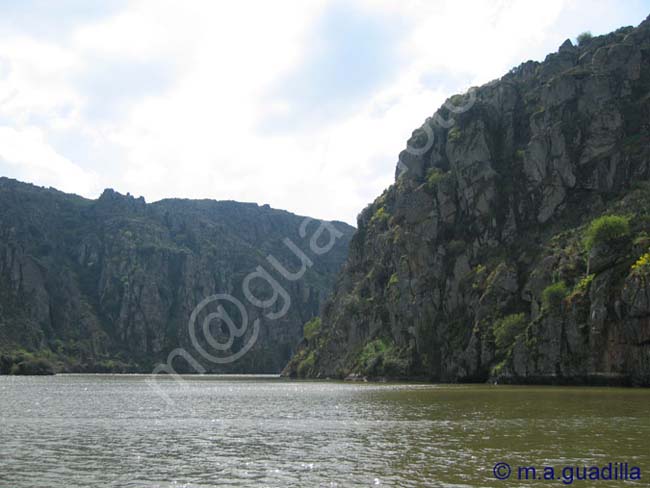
(285, 20, 650, 385)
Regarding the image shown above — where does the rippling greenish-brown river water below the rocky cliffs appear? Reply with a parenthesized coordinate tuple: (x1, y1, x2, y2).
(0, 375, 650, 488)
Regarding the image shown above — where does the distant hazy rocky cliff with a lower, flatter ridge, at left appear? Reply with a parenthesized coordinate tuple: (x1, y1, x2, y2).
(0, 178, 353, 373)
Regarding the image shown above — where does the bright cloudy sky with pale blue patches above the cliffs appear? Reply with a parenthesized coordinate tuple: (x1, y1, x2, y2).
(0, 0, 650, 225)
